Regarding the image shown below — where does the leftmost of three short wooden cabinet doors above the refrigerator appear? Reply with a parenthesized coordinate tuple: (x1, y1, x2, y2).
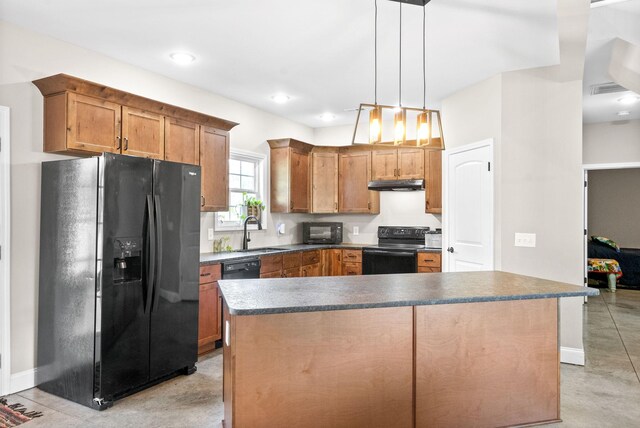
(67, 92, 122, 154)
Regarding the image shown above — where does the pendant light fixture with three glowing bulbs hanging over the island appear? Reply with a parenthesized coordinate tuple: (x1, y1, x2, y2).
(351, 0, 444, 150)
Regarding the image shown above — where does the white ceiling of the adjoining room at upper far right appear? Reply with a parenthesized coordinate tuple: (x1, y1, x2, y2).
(583, 0, 640, 123)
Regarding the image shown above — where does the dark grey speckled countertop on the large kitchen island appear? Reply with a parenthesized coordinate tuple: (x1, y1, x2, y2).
(219, 271, 599, 315)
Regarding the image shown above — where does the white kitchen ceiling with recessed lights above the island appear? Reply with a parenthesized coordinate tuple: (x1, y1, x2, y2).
(0, 0, 560, 127)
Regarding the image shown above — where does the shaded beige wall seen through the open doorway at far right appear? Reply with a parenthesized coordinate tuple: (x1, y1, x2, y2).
(587, 168, 640, 248)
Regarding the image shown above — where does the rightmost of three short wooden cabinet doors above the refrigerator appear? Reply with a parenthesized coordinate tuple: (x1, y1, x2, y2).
(164, 117, 200, 165)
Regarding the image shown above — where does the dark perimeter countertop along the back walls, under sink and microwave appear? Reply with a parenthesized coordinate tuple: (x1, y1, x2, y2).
(200, 243, 442, 265)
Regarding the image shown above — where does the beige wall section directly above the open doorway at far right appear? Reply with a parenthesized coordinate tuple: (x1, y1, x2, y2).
(582, 120, 640, 164)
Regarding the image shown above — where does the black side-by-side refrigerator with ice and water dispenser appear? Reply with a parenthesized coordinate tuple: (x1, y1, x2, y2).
(36, 154, 200, 409)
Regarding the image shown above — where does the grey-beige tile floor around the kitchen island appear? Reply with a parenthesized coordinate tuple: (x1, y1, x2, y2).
(9, 290, 640, 428)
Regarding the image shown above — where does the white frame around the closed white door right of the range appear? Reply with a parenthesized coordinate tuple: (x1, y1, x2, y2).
(442, 138, 496, 272)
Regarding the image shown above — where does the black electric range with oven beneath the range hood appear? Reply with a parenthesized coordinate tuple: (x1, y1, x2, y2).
(362, 226, 438, 275)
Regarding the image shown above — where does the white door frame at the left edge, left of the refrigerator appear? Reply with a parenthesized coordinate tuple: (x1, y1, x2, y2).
(0, 106, 11, 396)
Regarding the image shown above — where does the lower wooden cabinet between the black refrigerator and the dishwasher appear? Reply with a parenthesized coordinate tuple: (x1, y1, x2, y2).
(198, 265, 222, 355)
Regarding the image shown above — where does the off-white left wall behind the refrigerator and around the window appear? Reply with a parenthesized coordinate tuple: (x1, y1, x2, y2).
(0, 22, 313, 374)
